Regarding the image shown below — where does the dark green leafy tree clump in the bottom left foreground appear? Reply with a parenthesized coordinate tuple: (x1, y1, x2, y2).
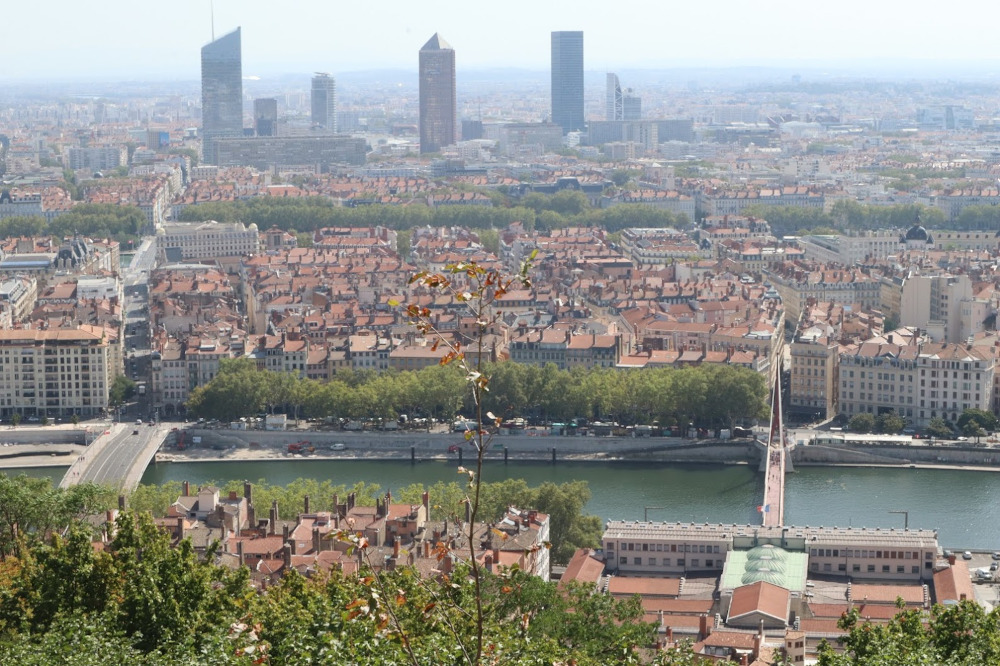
(0, 513, 253, 663)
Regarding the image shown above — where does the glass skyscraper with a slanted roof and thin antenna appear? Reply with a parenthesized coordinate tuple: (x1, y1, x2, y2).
(201, 28, 243, 164)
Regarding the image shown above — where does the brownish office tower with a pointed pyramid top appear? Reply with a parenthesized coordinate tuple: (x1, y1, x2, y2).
(420, 32, 458, 153)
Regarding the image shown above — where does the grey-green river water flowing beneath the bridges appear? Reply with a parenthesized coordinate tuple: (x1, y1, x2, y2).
(131, 460, 1000, 550)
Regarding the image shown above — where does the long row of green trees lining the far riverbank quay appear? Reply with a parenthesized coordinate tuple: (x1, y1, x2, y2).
(188, 359, 767, 427)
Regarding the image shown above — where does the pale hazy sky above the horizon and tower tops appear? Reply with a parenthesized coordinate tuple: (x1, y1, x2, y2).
(0, 0, 1000, 80)
